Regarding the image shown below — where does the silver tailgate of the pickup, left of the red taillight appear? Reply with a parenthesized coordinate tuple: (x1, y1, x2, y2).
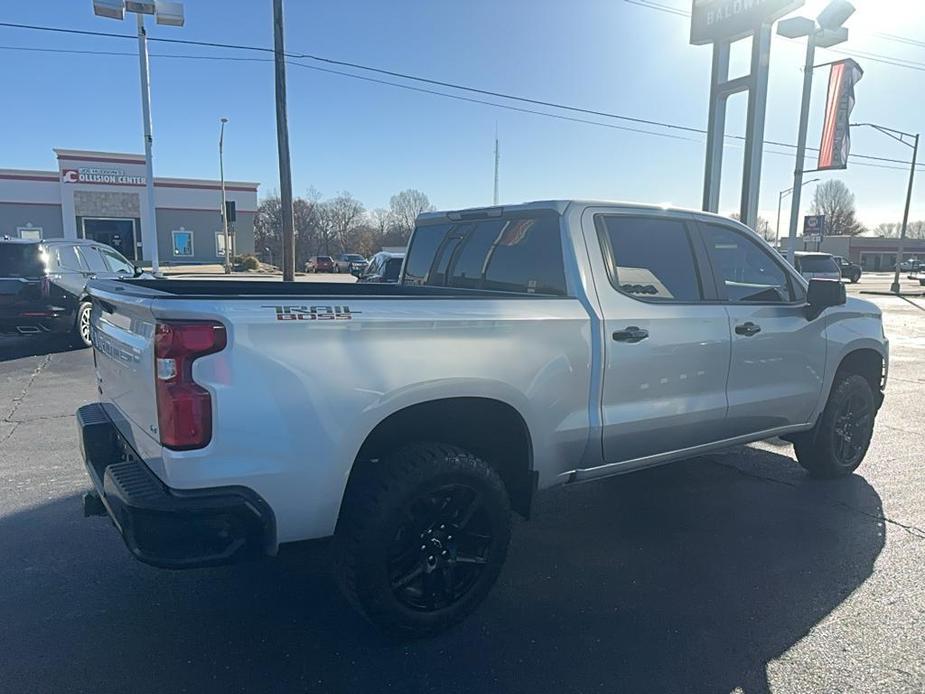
(90, 288, 161, 469)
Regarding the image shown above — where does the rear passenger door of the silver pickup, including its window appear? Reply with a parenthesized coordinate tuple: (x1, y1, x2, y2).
(585, 212, 730, 463)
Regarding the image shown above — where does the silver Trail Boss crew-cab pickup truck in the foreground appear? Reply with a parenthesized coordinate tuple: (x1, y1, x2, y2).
(78, 201, 888, 635)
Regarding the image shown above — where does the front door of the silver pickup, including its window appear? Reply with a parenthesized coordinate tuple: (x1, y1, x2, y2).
(701, 224, 826, 438)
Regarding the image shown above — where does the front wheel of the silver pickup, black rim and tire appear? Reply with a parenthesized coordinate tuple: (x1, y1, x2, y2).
(794, 374, 877, 478)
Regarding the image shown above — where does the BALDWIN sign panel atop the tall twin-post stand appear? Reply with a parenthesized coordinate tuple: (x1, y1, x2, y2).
(691, 0, 804, 45)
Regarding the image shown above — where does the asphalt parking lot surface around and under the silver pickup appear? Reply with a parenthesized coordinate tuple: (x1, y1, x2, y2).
(0, 276, 925, 694)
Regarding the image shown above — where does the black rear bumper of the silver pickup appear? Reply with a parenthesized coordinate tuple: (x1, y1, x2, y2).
(77, 403, 276, 569)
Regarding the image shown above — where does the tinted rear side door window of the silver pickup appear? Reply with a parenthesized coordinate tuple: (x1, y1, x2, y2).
(598, 215, 703, 302)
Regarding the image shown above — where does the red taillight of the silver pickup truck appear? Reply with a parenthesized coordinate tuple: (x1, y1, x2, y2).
(154, 321, 228, 450)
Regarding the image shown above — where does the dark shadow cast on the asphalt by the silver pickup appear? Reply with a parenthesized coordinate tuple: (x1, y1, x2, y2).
(0, 451, 884, 694)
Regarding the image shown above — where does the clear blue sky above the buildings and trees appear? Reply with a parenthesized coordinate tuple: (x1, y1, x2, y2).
(0, 0, 925, 234)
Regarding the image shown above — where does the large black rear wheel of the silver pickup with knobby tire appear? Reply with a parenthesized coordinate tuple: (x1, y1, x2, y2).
(334, 443, 511, 637)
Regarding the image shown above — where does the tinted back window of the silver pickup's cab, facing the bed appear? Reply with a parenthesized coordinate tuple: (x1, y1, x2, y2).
(404, 214, 567, 296)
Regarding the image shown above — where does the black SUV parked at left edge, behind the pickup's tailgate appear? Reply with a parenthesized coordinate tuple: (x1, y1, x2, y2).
(0, 239, 142, 347)
